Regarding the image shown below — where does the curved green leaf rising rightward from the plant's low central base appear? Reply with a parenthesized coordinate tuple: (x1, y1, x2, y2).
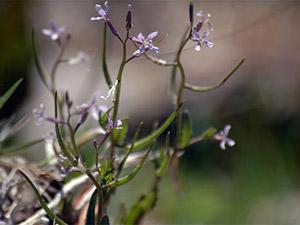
(103, 142, 154, 189)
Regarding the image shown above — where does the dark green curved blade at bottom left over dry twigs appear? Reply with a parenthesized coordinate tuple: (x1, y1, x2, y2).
(18, 169, 67, 225)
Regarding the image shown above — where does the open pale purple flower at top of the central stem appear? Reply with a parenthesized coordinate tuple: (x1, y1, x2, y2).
(132, 31, 159, 57)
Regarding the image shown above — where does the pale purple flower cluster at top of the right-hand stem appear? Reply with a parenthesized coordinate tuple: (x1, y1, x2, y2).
(190, 11, 214, 51)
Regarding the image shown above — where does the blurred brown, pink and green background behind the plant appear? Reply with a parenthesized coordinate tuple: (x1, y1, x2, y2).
(0, 0, 300, 224)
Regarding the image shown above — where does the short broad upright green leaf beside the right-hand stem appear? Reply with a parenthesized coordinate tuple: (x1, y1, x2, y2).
(179, 111, 193, 149)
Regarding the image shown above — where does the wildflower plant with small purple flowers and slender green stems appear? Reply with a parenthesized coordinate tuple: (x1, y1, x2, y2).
(0, 1, 244, 225)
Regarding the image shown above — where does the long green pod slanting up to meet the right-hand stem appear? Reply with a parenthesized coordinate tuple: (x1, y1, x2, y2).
(127, 109, 178, 152)
